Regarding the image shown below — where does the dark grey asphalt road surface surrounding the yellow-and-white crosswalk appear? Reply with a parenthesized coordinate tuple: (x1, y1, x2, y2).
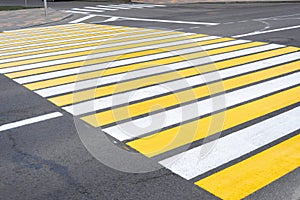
(0, 0, 300, 200)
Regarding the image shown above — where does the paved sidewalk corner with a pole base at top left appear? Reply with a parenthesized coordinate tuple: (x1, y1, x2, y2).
(0, 8, 72, 31)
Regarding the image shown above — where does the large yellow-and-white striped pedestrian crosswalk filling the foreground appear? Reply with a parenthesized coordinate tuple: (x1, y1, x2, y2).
(0, 24, 300, 199)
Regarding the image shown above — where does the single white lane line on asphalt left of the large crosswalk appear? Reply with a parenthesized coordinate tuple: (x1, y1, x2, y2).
(0, 112, 63, 131)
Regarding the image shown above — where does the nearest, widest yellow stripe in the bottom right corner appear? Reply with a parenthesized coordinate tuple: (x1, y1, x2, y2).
(195, 135, 300, 199)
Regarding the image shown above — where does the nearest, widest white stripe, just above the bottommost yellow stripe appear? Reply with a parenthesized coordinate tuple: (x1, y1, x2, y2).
(159, 107, 300, 180)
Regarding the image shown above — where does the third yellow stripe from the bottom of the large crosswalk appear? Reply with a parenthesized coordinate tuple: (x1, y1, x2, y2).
(81, 61, 300, 127)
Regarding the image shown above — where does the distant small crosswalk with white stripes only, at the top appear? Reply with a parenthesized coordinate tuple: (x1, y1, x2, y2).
(65, 3, 166, 14)
